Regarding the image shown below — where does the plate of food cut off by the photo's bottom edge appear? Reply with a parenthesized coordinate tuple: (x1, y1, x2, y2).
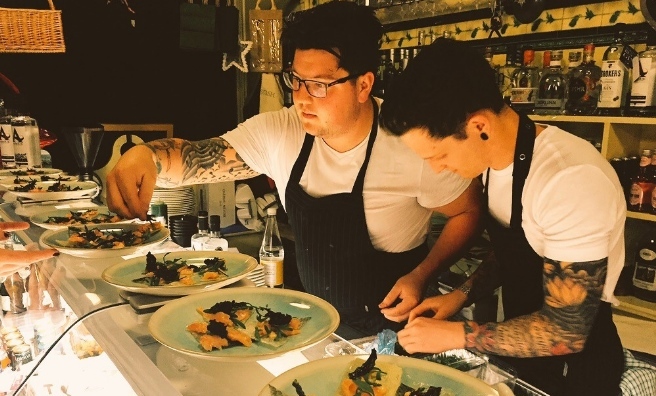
(259, 354, 498, 396)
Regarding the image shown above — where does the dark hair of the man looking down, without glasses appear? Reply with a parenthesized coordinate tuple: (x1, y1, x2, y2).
(380, 38, 505, 139)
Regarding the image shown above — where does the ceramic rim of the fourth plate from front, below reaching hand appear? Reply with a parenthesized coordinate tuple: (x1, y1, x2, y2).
(39, 223, 169, 258)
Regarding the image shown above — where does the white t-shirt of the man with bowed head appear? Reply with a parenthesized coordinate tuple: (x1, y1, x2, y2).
(489, 125, 626, 304)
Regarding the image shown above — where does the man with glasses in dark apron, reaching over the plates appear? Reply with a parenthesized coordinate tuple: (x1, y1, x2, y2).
(107, 1, 479, 337)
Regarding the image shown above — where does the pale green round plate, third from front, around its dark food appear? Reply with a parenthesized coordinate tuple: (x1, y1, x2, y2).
(102, 251, 257, 296)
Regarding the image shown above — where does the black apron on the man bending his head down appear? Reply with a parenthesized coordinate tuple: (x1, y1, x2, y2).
(485, 114, 624, 396)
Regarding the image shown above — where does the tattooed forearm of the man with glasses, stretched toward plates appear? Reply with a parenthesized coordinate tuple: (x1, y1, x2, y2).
(145, 137, 257, 187)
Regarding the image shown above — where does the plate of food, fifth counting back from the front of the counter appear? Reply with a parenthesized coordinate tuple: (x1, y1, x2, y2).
(30, 206, 129, 230)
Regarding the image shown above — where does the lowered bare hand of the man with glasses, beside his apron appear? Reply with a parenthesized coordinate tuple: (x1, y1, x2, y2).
(378, 271, 426, 322)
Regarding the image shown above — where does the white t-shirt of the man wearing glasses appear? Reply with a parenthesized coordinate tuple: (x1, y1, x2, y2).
(222, 103, 470, 252)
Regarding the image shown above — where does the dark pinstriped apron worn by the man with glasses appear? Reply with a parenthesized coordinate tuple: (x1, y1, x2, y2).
(285, 99, 428, 336)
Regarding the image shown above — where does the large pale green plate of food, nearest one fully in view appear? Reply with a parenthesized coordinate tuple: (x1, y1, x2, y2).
(148, 287, 339, 361)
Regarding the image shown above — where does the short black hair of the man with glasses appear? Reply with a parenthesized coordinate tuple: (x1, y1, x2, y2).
(281, 0, 383, 73)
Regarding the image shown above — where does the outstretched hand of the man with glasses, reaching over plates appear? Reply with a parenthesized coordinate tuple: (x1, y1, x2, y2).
(106, 145, 157, 220)
